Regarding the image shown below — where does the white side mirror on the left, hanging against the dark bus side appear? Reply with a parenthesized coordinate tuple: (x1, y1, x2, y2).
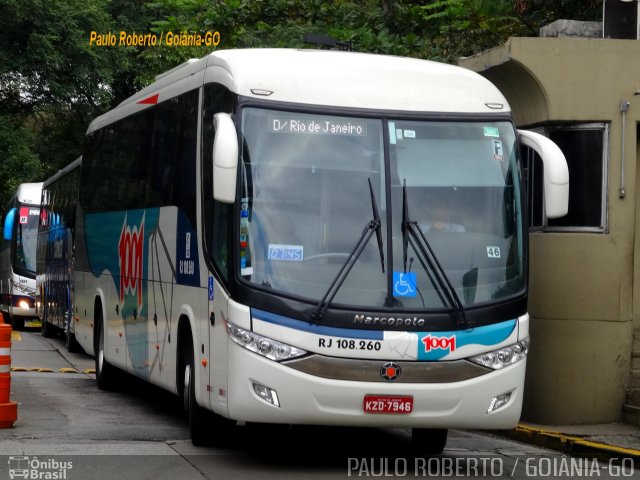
(213, 113, 238, 203)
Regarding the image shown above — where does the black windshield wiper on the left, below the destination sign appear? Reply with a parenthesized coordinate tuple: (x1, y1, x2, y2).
(311, 178, 384, 323)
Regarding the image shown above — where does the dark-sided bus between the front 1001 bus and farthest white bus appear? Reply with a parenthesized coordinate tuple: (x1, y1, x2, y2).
(36, 157, 82, 351)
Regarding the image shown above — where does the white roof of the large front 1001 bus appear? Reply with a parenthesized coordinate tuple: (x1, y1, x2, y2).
(89, 48, 509, 131)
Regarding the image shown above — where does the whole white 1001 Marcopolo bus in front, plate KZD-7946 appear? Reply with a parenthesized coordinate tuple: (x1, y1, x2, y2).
(75, 49, 568, 453)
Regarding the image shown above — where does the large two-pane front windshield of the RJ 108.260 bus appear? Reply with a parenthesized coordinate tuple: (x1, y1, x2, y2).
(232, 107, 525, 310)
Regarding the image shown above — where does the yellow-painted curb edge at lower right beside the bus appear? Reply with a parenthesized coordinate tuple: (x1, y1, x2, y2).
(501, 424, 640, 461)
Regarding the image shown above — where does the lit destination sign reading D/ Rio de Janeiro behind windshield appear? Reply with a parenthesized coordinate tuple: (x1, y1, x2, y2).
(269, 115, 367, 137)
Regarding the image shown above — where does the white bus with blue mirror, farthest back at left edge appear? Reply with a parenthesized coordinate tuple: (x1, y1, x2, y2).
(0, 183, 42, 330)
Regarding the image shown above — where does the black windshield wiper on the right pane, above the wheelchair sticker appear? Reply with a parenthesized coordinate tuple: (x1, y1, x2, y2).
(402, 179, 469, 327)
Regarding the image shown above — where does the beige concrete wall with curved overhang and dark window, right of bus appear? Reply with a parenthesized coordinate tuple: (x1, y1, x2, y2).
(460, 38, 640, 424)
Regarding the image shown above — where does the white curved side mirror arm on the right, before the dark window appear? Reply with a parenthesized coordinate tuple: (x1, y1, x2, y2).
(518, 130, 569, 218)
